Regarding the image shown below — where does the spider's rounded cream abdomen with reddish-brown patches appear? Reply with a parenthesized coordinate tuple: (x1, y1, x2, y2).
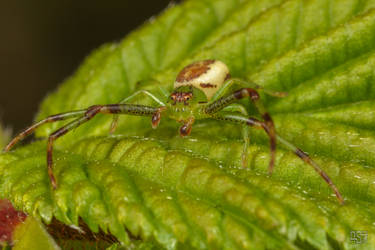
(174, 60, 230, 100)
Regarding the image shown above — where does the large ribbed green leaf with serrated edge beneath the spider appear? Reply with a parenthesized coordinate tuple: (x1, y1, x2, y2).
(0, 0, 375, 249)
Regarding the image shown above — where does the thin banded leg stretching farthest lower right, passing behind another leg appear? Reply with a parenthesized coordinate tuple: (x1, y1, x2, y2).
(211, 114, 344, 204)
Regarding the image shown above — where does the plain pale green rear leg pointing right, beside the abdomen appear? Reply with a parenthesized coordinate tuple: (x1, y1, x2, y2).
(210, 78, 287, 103)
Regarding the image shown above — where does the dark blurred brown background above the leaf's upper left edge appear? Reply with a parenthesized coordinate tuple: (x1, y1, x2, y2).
(0, 0, 175, 132)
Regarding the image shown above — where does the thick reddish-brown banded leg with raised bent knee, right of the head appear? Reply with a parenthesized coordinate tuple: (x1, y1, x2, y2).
(204, 88, 276, 174)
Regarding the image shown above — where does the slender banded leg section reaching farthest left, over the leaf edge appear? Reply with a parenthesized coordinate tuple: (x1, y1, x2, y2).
(4, 110, 86, 152)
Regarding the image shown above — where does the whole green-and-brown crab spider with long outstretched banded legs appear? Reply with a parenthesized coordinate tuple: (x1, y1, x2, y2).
(4, 60, 344, 204)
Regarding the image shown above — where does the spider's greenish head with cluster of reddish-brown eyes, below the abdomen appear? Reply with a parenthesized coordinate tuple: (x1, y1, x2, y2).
(168, 86, 207, 106)
